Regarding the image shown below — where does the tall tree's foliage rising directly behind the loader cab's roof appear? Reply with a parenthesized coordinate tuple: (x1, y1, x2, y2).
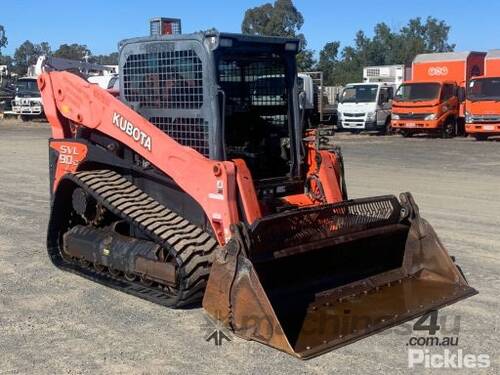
(241, 0, 315, 70)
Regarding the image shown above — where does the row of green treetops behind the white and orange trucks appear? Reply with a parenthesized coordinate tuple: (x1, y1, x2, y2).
(317, 17, 455, 85)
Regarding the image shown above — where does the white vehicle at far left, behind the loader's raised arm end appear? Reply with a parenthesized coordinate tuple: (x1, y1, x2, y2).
(12, 77, 43, 121)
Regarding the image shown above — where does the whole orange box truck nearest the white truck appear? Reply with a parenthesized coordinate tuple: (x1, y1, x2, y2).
(391, 52, 486, 138)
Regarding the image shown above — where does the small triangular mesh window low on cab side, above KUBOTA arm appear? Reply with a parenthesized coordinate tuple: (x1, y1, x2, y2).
(149, 117, 209, 156)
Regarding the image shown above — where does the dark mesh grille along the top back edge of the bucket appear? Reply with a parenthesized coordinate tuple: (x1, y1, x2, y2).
(251, 196, 401, 252)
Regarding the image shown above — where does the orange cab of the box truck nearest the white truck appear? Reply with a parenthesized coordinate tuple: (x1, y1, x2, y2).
(392, 81, 460, 137)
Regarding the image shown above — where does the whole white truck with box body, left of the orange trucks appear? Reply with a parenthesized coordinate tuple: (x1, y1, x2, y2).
(337, 65, 407, 133)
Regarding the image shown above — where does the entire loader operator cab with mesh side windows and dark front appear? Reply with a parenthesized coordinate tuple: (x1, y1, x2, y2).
(120, 32, 303, 194)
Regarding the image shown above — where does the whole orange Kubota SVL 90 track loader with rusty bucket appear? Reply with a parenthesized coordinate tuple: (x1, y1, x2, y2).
(38, 33, 475, 358)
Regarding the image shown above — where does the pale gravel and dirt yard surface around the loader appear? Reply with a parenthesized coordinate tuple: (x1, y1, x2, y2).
(0, 121, 500, 374)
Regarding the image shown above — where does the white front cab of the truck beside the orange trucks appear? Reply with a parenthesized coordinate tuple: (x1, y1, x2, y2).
(338, 82, 396, 132)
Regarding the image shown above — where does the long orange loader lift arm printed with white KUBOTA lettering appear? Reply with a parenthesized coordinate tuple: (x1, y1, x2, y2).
(38, 72, 238, 244)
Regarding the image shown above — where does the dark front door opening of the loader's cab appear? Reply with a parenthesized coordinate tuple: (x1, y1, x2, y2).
(215, 37, 297, 180)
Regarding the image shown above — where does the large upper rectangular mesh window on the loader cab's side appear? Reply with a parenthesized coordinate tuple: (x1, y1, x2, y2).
(123, 50, 203, 109)
